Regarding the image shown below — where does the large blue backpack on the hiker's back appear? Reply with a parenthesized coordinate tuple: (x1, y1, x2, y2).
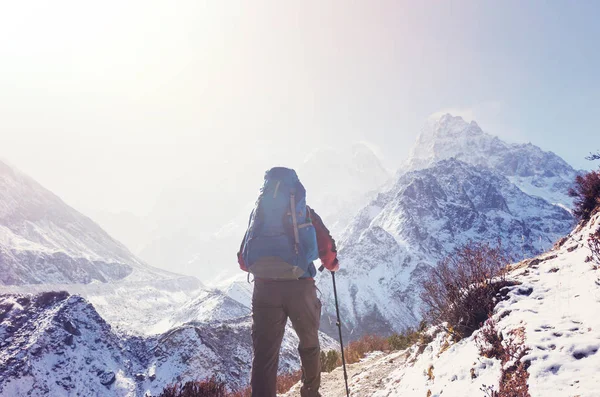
(242, 167, 319, 279)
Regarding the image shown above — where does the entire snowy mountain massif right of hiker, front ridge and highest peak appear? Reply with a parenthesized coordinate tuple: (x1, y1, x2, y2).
(310, 115, 577, 336)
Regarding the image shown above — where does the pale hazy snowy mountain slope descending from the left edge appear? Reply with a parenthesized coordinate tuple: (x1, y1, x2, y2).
(0, 158, 172, 285)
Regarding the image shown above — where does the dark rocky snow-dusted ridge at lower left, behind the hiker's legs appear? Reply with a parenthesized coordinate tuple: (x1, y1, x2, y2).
(0, 292, 334, 397)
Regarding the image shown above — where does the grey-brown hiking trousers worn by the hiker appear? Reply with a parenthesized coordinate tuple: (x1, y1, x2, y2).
(251, 279, 321, 397)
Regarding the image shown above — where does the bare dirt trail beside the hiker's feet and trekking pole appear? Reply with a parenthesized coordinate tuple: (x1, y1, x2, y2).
(280, 350, 409, 397)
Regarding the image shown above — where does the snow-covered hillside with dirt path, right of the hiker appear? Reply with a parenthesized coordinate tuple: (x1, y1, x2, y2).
(285, 213, 600, 397)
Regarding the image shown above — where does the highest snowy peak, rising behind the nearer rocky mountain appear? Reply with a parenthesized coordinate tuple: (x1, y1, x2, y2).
(406, 114, 578, 208)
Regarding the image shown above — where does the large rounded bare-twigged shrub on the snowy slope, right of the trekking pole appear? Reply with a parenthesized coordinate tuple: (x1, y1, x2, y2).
(421, 242, 514, 339)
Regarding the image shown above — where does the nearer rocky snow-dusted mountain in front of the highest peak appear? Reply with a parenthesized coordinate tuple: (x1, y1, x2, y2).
(320, 159, 573, 337)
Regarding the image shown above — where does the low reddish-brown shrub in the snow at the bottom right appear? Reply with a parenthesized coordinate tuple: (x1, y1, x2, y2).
(476, 319, 531, 397)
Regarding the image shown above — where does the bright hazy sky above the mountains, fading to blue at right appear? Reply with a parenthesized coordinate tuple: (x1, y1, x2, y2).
(0, 0, 600, 214)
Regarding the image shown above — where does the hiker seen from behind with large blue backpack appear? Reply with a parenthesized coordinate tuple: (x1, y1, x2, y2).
(238, 167, 339, 397)
